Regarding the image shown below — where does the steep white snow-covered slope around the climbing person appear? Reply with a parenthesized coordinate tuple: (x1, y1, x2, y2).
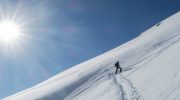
(4, 12, 180, 100)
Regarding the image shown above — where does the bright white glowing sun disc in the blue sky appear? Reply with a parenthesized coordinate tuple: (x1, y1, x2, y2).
(0, 21, 21, 43)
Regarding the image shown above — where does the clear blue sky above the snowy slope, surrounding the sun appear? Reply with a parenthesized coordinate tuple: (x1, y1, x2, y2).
(0, 0, 180, 98)
